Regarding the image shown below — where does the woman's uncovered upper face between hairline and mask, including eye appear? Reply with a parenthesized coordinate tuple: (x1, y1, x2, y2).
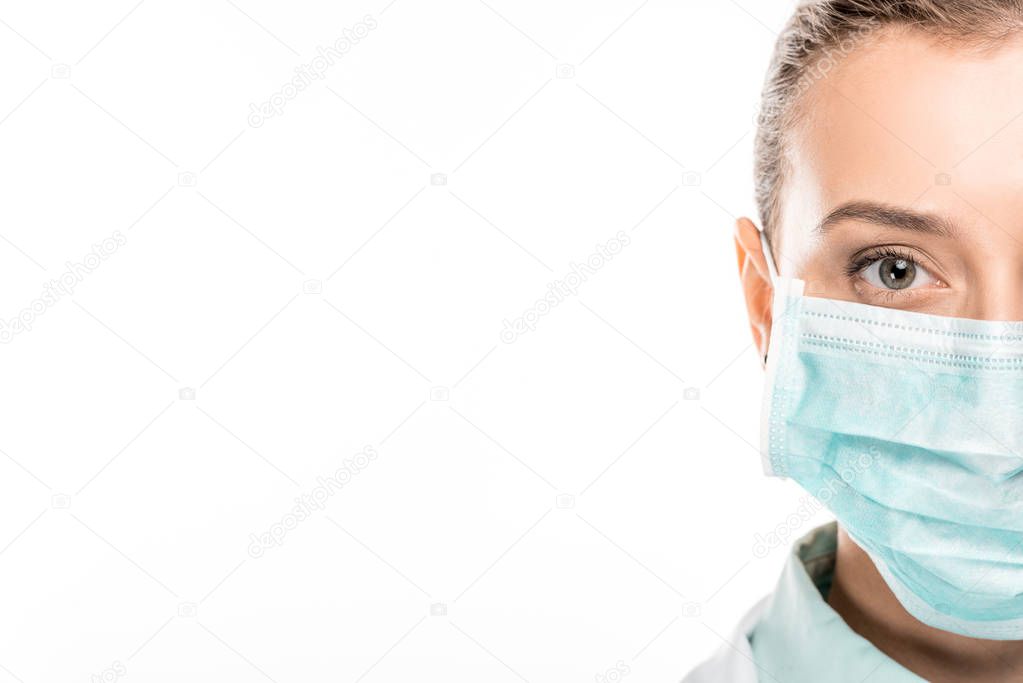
(769, 27, 1023, 325)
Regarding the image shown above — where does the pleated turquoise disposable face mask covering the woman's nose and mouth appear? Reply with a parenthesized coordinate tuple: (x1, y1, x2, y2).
(761, 233, 1023, 640)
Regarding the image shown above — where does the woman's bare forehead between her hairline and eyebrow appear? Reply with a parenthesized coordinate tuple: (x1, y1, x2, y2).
(783, 30, 1023, 236)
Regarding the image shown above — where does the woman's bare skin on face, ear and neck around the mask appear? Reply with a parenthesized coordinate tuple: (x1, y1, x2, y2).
(735, 28, 1023, 682)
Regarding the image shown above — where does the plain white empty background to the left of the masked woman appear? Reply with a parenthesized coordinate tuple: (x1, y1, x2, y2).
(0, 0, 822, 683)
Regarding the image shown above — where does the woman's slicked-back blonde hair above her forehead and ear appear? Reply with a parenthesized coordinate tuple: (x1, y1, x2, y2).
(754, 0, 1023, 241)
